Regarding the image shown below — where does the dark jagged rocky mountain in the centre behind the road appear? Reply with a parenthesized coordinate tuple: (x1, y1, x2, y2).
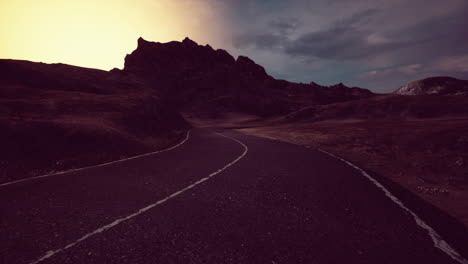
(121, 38, 374, 115)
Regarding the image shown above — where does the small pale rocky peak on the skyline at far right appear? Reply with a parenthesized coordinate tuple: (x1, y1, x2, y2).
(394, 77, 468, 96)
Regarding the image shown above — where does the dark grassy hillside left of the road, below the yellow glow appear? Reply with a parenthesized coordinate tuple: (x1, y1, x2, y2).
(0, 60, 188, 182)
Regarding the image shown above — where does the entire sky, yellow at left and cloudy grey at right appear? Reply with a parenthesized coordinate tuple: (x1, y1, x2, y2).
(0, 0, 468, 92)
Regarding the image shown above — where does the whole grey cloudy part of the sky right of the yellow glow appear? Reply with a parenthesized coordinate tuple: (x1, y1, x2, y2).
(221, 0, 468, 91)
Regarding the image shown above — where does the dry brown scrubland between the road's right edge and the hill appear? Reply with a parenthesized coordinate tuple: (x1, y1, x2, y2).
(239, 118, 468, 226)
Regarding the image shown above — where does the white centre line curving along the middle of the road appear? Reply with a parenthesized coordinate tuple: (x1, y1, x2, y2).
(31, 133, 249, 264)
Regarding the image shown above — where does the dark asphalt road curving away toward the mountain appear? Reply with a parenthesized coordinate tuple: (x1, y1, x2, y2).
(0, 129, 466, 264)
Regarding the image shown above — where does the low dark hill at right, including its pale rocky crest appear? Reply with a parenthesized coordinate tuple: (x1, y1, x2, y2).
(287, 77, 468, 122)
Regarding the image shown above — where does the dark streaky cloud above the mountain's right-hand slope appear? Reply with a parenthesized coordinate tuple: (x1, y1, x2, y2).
(234, 9, 409, 60)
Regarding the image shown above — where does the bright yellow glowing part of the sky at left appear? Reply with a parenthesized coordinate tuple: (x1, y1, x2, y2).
(0, 0, 227, 70)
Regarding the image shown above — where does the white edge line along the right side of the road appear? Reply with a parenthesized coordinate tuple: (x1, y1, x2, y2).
(318, 149, 468, 264)
